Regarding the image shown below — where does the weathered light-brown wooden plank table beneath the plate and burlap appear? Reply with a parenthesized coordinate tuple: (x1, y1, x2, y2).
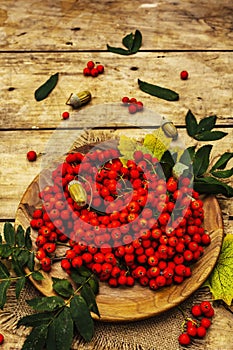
(0, 0, 233, 350)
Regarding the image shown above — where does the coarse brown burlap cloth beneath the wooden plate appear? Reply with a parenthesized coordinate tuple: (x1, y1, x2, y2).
(0, 282, 215, 350)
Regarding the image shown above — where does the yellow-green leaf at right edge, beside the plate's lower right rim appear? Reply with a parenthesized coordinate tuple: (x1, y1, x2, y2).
(204, 234, 233, 306)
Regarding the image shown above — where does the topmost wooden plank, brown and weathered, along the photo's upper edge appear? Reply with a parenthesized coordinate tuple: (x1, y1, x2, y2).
(0, 0, 233, 51)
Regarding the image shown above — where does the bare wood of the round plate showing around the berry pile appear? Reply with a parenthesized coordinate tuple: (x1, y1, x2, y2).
(16, 177, 223, 321)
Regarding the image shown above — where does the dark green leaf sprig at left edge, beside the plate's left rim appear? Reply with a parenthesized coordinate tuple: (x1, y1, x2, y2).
(0, 222, 43, 309)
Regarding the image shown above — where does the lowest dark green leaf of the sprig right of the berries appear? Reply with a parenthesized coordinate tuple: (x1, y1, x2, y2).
(194, 176, 233, 198)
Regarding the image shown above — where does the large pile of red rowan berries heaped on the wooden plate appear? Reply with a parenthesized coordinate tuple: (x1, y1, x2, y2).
(31, 148, 210, 290)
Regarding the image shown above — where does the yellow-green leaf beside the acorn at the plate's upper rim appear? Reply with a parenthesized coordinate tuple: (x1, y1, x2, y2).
(143, 128, 171, 160)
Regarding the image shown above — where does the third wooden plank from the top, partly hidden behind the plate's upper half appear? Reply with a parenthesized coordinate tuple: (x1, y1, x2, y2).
(0, 128, 233, 220)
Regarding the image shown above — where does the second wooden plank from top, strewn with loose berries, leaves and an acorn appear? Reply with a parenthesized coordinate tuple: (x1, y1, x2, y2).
(0, 52, 233, 129)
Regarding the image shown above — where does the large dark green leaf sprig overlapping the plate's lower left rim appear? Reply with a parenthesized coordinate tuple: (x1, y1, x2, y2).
(17, 267, 100, 350)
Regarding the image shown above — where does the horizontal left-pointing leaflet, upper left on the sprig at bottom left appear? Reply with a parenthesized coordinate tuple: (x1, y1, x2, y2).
(27, 296, 65, 311)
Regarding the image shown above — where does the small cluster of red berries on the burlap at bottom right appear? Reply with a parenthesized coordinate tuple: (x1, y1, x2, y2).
(178, 301, 214, 345)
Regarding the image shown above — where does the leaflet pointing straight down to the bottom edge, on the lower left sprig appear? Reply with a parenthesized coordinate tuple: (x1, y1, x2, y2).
(54, 307, 74, 350)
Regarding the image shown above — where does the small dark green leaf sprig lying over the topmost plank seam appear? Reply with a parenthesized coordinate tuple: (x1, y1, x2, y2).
(107, 30, 142, 56)
